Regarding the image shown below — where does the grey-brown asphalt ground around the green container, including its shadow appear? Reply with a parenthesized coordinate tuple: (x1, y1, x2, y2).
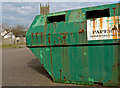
(2, 47, 117, 88)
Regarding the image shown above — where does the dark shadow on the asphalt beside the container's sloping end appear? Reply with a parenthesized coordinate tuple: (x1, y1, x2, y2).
(28, 58, 53, 81)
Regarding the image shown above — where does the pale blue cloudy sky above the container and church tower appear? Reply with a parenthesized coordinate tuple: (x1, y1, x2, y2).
(0, 0, 119, 27)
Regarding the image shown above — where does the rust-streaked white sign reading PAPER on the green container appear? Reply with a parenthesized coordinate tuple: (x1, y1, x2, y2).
(87, 16, 120, 40)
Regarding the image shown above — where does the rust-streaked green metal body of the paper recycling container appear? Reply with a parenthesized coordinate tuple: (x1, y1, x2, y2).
(26, 3, 120, 86)
